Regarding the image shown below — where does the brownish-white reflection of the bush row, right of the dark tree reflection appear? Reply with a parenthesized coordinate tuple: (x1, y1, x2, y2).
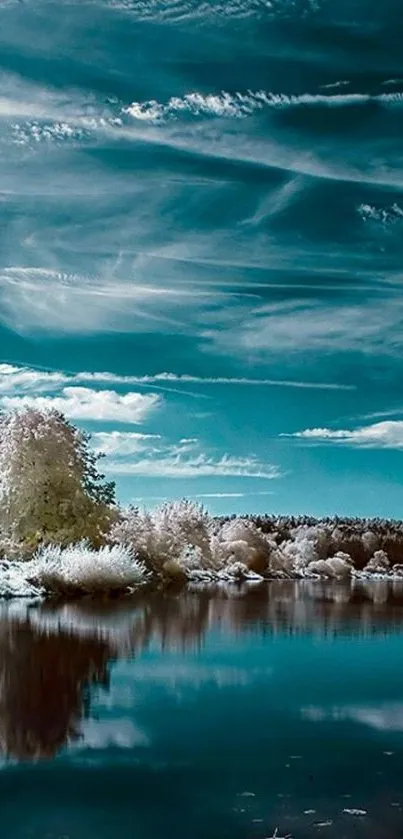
(125, 581, 403, 650)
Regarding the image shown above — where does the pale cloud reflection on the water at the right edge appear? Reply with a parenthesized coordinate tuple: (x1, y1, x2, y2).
(301, 702, 403, 731)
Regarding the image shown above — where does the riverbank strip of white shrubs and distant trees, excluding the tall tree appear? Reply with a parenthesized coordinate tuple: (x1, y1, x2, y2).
(0, 508, 403, 598)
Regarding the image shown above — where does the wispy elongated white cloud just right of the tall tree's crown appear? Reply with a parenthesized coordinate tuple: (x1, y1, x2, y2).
(104, 449, 280, 480)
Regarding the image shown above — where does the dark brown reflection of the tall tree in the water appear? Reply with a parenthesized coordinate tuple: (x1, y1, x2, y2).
(0, 620, 110, 759)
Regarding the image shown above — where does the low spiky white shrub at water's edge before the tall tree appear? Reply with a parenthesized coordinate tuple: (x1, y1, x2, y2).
(26, 542, 149, 595)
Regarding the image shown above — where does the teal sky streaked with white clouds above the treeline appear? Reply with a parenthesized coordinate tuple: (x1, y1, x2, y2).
(0, 0, 403, 518)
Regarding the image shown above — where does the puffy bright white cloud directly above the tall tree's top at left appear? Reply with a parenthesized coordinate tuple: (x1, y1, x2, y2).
(0, 387, 162, 423)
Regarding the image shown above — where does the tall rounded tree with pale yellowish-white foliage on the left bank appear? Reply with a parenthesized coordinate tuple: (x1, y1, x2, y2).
(0, 408, 118, 551)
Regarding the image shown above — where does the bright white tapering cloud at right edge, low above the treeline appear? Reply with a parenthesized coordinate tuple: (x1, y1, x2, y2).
(286, 420, 403, 449)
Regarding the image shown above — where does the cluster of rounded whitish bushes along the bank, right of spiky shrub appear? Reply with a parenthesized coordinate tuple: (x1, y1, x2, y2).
(112, 501, 360, 578)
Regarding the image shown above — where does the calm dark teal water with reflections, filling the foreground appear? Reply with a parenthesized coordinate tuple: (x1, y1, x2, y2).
(0, 583, 403, 839)
